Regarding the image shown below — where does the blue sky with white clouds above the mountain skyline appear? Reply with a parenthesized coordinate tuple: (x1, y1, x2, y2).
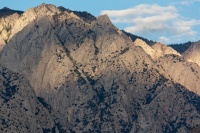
(0, 0, 200, 44)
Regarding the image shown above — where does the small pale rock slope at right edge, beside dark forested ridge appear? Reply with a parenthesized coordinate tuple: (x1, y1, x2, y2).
(182, 41, 200, 66)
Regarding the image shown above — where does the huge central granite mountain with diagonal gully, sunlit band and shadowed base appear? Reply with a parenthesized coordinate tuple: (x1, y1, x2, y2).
(0, 4, 200, 133)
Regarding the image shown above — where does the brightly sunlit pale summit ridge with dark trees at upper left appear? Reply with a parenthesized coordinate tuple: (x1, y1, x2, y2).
(0, 3, 106, 51)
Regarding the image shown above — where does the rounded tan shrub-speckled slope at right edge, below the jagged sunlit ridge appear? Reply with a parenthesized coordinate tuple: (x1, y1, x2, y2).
(157, 55, 200, 95)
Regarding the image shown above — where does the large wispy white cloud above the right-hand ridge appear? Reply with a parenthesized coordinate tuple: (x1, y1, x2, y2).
(101, 3, 200, 43)
